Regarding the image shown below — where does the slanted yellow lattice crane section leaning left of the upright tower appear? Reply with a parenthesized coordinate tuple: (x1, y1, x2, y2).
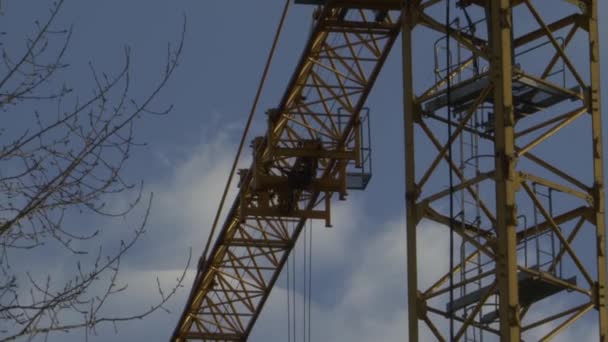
(173, 0, 401, 341)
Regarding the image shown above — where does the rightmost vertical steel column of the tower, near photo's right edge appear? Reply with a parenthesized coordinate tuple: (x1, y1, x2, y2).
(586, 0, 608, 341)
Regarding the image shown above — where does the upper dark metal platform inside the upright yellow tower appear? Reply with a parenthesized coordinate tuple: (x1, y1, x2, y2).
(422, 72, 582, 118)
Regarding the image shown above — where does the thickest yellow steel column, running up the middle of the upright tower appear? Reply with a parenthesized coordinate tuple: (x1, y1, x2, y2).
(488, 0, 521, 342)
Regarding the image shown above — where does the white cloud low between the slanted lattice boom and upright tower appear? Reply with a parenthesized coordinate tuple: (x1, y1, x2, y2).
(251, 210, 447, 342)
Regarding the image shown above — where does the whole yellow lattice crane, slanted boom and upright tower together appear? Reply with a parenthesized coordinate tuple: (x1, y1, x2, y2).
(172, 0, 608, 342)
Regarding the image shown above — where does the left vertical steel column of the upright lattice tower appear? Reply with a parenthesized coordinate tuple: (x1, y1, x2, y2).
(401, 0, 421, 341)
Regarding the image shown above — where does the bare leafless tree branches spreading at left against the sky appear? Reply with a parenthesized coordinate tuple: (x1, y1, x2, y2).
(0, 0, 190, 341)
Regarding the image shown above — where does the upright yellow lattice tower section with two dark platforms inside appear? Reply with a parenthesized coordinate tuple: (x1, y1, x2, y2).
(403, 0, 608, 341)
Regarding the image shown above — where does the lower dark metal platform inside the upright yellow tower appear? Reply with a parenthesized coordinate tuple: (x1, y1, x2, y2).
(446, 272, 576, 324)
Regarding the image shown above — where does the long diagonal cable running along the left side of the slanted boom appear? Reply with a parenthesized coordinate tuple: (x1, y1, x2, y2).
(201, 0, 291, 261)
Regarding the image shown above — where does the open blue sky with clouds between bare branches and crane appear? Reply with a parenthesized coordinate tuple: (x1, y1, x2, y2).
(0, 0, 608, 341)
